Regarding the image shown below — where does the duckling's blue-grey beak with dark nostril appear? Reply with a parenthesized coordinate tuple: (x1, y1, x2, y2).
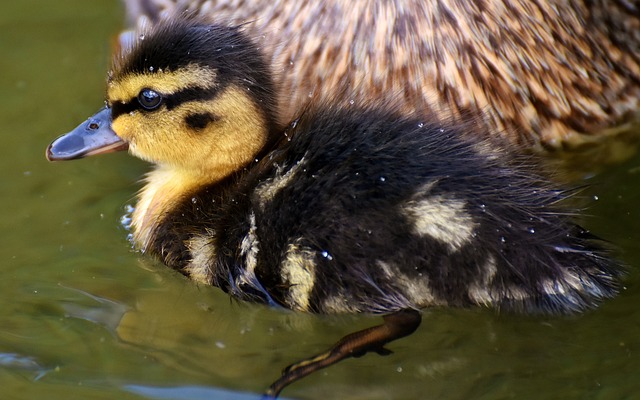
(46, 107, 129, 161)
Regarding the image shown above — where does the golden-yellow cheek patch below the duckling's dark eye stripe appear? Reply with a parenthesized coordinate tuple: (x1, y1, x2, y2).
(112, 86, 268, 179)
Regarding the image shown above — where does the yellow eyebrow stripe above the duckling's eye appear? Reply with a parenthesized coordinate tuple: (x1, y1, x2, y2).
(107, 64, 217, 103)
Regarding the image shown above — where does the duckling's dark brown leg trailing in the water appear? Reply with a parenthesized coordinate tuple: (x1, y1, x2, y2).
(264, 310, 422, 398)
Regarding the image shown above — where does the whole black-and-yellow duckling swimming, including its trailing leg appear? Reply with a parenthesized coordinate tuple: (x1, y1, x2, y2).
(47, 16, 621, 395)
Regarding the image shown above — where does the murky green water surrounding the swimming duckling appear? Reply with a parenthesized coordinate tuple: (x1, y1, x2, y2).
(0, 0, 640, 400)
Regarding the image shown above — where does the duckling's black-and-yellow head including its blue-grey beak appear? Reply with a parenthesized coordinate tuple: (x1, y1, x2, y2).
(47, 18, 276, 181)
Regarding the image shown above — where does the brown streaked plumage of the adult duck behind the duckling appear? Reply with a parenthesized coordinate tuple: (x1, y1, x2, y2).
(123, 0, 640, 170)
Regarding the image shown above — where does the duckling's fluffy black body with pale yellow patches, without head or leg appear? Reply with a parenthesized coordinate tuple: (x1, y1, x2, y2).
(162, 107, 620, 313)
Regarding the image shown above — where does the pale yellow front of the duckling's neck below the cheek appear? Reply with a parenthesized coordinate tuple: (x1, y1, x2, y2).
(131, 165, 224, 251)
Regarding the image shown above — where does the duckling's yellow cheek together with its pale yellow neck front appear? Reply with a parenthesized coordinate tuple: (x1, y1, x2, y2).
(112, 75, 268, 249)
